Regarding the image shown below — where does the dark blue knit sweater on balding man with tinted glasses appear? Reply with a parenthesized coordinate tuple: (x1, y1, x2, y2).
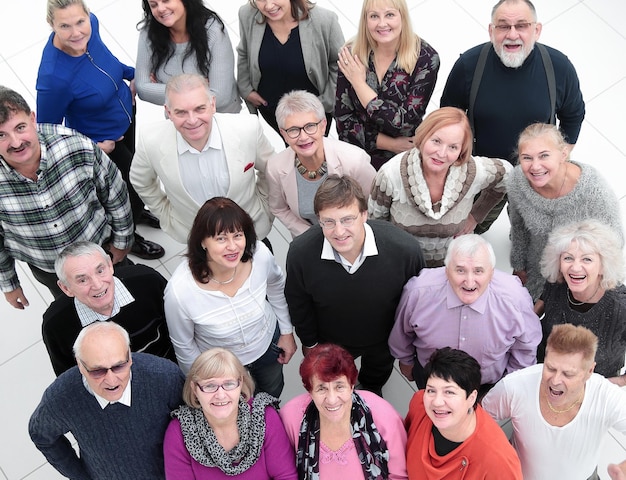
(28, 353, 185, 480)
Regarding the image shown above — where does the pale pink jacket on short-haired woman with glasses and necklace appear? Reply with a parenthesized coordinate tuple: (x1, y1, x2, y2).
(266, 137, 376, 237)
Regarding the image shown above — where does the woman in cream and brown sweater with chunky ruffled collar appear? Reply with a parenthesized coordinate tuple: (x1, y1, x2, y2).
(368, 107, 513, 267)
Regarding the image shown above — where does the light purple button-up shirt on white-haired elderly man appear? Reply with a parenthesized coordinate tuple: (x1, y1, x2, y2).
(389, 267, 542, 384)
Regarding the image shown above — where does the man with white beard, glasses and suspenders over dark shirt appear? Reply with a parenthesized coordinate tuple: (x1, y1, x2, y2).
(441, 0, 585, 233)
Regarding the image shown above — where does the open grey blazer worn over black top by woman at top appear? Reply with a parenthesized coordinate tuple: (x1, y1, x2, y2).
(237, 2, 344, 113)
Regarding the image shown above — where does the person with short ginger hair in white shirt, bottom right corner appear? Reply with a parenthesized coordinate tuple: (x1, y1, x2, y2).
(482, 323, 626, 480)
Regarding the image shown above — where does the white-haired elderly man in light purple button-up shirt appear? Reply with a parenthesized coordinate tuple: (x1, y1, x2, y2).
(389, 234, 541, 396)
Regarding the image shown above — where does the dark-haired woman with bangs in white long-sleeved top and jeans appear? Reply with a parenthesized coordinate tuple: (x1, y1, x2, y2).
(165, 197, 296, 397)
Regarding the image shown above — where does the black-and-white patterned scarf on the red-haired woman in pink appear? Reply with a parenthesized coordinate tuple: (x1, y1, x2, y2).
(296, 392, 389, 480)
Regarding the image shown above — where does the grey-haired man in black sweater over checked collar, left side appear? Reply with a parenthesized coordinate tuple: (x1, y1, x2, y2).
(42, 242, 176, 376)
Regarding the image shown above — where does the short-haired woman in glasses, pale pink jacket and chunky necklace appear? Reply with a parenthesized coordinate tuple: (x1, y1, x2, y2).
(266, 90, 376, 237)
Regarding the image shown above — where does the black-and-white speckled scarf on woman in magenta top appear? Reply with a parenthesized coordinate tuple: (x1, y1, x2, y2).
(171, 393, 279, 475)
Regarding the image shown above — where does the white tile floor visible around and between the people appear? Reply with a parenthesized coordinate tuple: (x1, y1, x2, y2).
(0, 0, 626, 480)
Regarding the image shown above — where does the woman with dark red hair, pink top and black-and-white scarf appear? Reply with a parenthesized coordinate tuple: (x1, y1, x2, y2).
(280, 344, 407, 480)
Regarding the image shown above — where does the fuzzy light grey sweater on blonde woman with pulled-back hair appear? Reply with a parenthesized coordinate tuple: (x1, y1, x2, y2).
(506, 162, 623, 301)
